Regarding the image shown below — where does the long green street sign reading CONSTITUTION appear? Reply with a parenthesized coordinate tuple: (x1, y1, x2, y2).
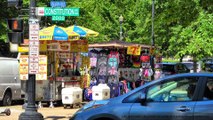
(36, 7, 79, 16)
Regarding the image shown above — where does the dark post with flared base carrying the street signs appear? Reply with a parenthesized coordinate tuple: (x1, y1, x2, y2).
(19, 0, 43, 120)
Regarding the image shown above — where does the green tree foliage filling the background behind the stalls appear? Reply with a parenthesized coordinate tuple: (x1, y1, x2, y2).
(0, 0, 213, 59)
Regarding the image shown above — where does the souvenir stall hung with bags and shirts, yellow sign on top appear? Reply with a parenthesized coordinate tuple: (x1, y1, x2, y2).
(85, 40, 150, 100)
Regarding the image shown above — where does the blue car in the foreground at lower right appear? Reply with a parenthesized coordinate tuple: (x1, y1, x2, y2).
(70, 73, 213, 120)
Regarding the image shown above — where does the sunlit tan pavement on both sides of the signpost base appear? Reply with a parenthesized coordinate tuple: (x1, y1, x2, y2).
(0, 105, 79, 120)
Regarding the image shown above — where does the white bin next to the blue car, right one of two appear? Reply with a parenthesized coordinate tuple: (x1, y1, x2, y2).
(92, 84, 110, 100)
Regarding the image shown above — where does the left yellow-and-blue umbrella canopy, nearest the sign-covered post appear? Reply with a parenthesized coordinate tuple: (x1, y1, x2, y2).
(39, 25, 79, 41)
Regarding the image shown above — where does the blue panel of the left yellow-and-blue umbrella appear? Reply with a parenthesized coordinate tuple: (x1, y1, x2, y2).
(53, 27, 68, 40)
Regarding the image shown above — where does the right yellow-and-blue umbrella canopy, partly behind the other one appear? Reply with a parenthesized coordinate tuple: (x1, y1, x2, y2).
(66, 25, 99, 37)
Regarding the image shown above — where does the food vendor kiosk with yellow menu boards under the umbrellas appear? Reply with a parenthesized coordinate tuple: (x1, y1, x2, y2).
(19, 40, 88, 107)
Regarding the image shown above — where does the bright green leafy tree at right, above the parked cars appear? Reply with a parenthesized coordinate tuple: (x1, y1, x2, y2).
(167, 0, 213, 61)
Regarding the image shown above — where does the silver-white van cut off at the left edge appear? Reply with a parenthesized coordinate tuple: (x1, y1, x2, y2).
(0, 57, 22, 106)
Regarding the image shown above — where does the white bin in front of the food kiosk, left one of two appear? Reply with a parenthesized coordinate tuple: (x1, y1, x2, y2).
(62, 87, 82, 108)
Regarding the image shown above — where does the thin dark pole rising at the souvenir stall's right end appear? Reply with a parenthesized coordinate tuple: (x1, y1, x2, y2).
(150, 0, 155, 80)
